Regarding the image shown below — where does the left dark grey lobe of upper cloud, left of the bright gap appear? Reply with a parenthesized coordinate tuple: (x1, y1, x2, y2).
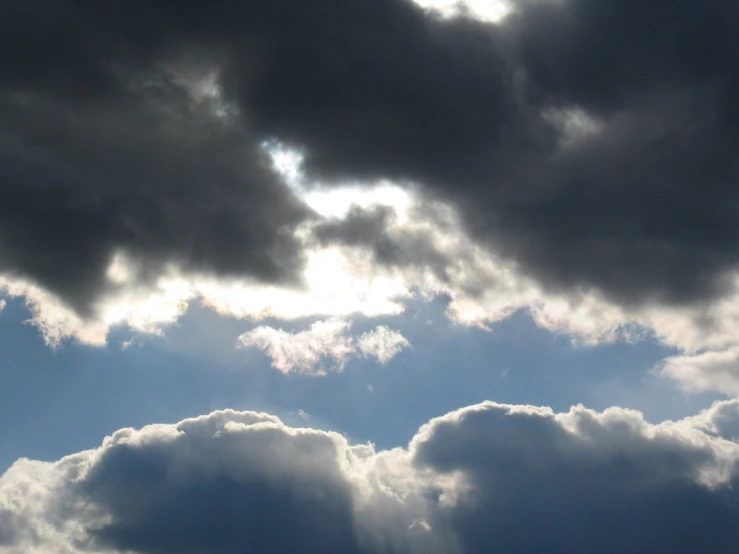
(0, 1, 309, 313)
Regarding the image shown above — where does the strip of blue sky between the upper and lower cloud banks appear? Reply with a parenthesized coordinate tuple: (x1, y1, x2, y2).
(0, 294, 715, 468)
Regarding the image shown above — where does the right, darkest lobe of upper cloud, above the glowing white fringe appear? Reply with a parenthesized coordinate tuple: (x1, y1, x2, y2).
(228, 0, 739, 302)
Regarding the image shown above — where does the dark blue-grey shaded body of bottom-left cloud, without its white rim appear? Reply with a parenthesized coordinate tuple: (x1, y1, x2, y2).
(84, 424, 358, 554)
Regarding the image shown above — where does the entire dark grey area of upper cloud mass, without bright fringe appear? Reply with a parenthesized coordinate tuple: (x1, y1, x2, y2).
(0, 0, 739, 307)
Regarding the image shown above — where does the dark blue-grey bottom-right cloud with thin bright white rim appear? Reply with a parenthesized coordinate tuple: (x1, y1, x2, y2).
(410, 396, 739, 553)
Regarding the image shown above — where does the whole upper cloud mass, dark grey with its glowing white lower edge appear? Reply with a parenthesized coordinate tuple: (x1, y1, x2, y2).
(0, 0, 739, 402)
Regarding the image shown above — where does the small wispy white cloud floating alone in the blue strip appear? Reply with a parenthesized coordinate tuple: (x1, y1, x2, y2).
(237, 318, 410, 375)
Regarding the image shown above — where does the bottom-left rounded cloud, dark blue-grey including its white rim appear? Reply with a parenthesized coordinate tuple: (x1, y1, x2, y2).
(3, 412, 370, 554)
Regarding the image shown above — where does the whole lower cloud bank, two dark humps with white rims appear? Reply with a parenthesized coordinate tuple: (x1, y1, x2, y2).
(0, 401, 739, 554)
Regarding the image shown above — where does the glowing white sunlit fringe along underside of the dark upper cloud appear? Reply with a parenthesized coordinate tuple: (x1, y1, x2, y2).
(7, 143, 739, 406)
